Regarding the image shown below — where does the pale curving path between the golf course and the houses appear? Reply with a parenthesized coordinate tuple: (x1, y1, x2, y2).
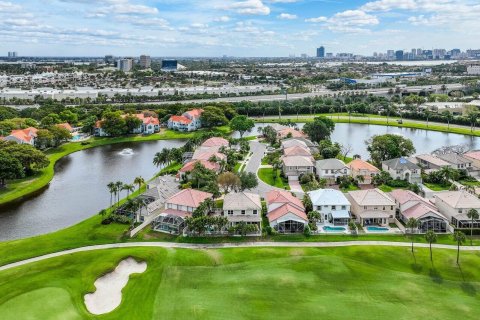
(0, 241, 480, 271)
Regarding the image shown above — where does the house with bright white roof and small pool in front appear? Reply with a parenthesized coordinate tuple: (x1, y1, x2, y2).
(308, 189, 350, 225)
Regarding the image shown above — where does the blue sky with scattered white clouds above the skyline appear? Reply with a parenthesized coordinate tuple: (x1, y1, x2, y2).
(0, 0, 480, 57)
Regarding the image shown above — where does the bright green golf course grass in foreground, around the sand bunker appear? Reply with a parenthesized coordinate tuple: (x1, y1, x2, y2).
(0, 247, 480, 320)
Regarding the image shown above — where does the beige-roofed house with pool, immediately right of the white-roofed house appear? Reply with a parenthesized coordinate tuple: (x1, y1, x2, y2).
(347, 189, 396, 226)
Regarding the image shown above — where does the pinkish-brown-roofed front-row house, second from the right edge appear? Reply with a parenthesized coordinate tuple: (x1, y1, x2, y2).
(390, 189, 449, 233)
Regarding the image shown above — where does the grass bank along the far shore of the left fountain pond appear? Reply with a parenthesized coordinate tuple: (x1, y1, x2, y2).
(0, 126, 230, 205)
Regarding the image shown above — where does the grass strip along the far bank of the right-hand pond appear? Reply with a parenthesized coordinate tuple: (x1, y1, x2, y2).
(255, 114, 480, 137)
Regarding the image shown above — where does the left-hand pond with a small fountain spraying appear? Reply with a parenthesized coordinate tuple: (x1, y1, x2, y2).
(0, 140, 184, 241)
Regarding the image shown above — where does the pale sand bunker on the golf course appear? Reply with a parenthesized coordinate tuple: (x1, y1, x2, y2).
(85, 258, 147, 314)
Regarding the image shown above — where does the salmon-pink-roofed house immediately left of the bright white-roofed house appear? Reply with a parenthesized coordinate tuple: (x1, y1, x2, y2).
(266, 190, 308, 233)
